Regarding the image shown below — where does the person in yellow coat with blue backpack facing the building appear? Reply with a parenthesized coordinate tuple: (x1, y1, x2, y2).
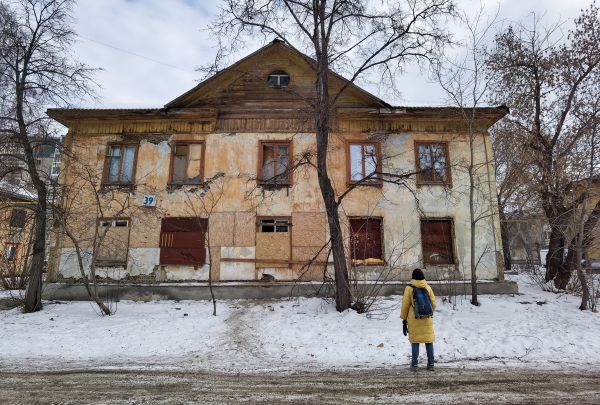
(400, 269, 435, 371)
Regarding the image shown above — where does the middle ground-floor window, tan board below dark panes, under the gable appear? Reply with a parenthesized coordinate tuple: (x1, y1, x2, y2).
(256, 218, 291, 267)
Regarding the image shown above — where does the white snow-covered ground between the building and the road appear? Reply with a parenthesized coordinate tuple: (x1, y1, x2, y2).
(0, 276, 600, 371)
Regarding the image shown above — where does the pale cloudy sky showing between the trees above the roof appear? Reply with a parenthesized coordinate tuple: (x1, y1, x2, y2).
(69, 0, 591, 108)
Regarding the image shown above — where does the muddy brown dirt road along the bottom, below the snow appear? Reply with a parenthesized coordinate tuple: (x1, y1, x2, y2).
(0, 368, 600, 405)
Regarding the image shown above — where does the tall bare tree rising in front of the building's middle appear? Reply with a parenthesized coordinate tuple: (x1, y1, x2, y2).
(211, 0, 454, 311)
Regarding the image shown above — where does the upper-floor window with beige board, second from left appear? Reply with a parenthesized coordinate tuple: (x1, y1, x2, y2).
(171, 142, 204, 184)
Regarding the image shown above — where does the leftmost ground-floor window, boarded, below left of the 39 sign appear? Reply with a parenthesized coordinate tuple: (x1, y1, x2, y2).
(96, 218, 129, 267)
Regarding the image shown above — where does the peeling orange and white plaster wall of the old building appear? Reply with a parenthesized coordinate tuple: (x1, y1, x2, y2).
(54, 128, 501, 281)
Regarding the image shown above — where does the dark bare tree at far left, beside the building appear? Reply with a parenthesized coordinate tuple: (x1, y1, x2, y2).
(0, 0, 93, 312)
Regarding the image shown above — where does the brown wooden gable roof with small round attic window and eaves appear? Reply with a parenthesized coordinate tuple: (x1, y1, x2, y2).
(47, 39, 508, 131)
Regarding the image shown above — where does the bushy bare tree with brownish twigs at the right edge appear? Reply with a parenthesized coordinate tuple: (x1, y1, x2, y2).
(488, 3, 600, 288)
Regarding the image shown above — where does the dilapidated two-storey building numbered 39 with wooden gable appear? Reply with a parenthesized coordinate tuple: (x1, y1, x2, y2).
(48, 41, 506, 282)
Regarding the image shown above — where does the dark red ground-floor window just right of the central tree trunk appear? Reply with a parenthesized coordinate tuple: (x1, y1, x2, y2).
(350, 217, 383, 260)
